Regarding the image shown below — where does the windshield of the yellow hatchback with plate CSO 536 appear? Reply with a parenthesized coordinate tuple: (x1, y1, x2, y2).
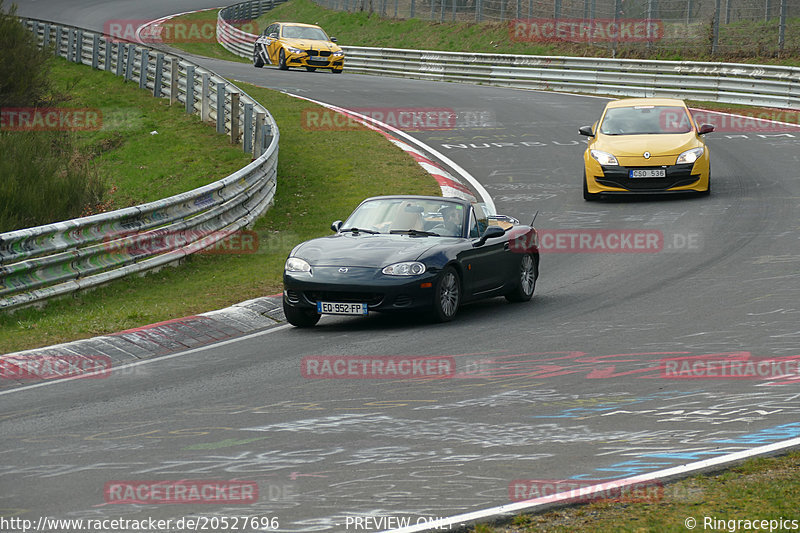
(600, 105, 692, 135)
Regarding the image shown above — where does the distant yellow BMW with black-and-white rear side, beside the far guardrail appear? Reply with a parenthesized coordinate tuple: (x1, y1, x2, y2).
(253, 22, 344, 74)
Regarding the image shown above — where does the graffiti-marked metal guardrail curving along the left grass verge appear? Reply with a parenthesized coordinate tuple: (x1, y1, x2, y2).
(0, 19, 279, 309)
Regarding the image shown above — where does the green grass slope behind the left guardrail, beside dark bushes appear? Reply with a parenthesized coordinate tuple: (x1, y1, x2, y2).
(47, 59, 252, 209)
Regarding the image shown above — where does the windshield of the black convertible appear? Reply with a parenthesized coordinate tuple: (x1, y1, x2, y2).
(340, 198, 467, 237)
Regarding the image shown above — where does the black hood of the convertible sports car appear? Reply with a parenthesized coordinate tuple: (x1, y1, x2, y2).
(292, 233, 457, 268)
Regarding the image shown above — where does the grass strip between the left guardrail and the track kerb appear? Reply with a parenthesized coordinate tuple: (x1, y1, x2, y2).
(0, 78, 441, 353)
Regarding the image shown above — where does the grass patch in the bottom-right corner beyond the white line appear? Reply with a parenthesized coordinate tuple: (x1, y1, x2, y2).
(473, 452, 800, 533)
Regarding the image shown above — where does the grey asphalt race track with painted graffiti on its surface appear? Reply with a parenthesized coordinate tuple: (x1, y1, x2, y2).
(6, 0, 800, 532)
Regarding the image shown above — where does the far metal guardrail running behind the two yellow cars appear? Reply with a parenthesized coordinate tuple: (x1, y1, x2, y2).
(217, 0, 800, 109)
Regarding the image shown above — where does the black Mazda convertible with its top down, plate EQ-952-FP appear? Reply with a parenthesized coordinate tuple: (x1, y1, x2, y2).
(283, 196, 539, 327)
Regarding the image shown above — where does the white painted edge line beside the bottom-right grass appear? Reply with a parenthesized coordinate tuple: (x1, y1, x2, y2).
(381, 438, 800, 533)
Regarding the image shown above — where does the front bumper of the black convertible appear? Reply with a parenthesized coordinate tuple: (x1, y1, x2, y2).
(283, 267, 437, 311)
